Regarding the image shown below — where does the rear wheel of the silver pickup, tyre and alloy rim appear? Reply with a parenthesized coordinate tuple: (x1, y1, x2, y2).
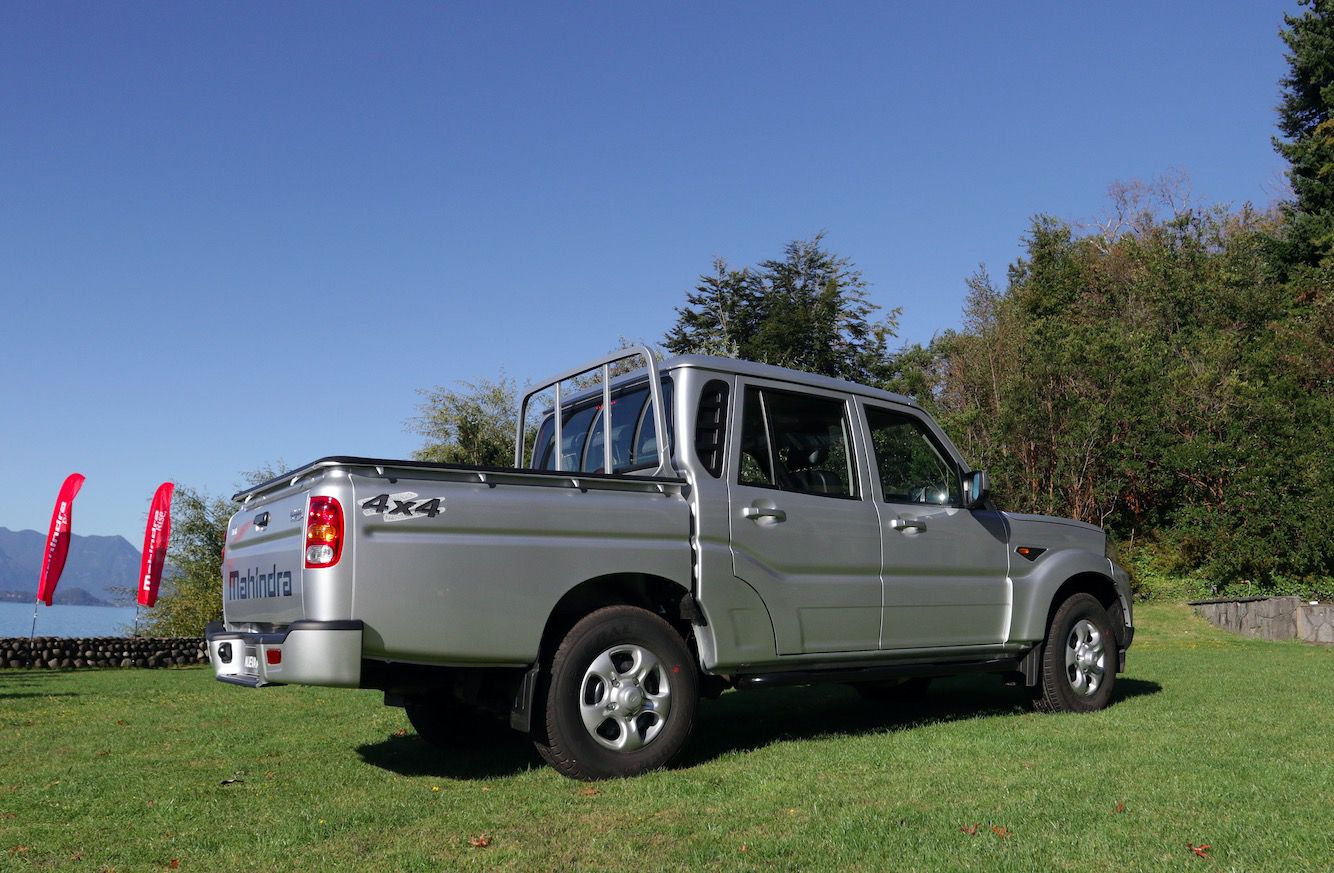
(534, 606, 699, 781)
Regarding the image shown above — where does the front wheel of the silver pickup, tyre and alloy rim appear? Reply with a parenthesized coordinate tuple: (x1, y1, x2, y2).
(1029, 594, 1117, 713)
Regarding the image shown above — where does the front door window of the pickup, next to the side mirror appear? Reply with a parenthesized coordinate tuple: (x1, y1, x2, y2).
(866, 406, 960, 506)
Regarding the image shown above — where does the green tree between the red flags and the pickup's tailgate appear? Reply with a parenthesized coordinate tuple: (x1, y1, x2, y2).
(144, 461, 285, 637)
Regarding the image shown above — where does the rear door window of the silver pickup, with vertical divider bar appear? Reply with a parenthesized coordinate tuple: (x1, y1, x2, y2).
(736, 387, 856, 498)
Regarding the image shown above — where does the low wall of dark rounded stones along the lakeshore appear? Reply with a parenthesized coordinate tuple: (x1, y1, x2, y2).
(0, 637, 208, 670)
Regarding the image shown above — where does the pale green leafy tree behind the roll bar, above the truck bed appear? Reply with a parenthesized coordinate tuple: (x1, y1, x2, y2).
(412, 374, 519, 467)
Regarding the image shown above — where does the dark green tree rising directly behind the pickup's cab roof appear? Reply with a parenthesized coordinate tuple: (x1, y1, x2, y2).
(663, 234, 899, 383)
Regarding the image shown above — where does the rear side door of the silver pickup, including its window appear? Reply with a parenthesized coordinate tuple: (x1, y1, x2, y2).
(728, 380, 882, 654)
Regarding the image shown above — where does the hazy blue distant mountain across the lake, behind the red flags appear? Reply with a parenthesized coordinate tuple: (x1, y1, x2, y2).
(0, 527, 139, 606)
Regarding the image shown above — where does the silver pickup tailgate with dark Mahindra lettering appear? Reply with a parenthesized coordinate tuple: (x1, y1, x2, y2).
(223, 491, 308, 626)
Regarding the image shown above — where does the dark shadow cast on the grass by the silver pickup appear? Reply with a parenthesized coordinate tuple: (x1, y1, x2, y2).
(356, 677, 1162, 780)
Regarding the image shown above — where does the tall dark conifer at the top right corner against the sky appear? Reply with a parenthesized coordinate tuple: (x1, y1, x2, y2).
(1274, 0, 1334, 264)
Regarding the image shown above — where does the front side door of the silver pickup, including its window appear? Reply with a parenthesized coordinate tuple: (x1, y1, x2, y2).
(864, 403, 1010, 649)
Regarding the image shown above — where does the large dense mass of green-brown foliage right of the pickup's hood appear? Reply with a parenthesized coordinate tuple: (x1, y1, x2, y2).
(899, 202, 1334, 603)
